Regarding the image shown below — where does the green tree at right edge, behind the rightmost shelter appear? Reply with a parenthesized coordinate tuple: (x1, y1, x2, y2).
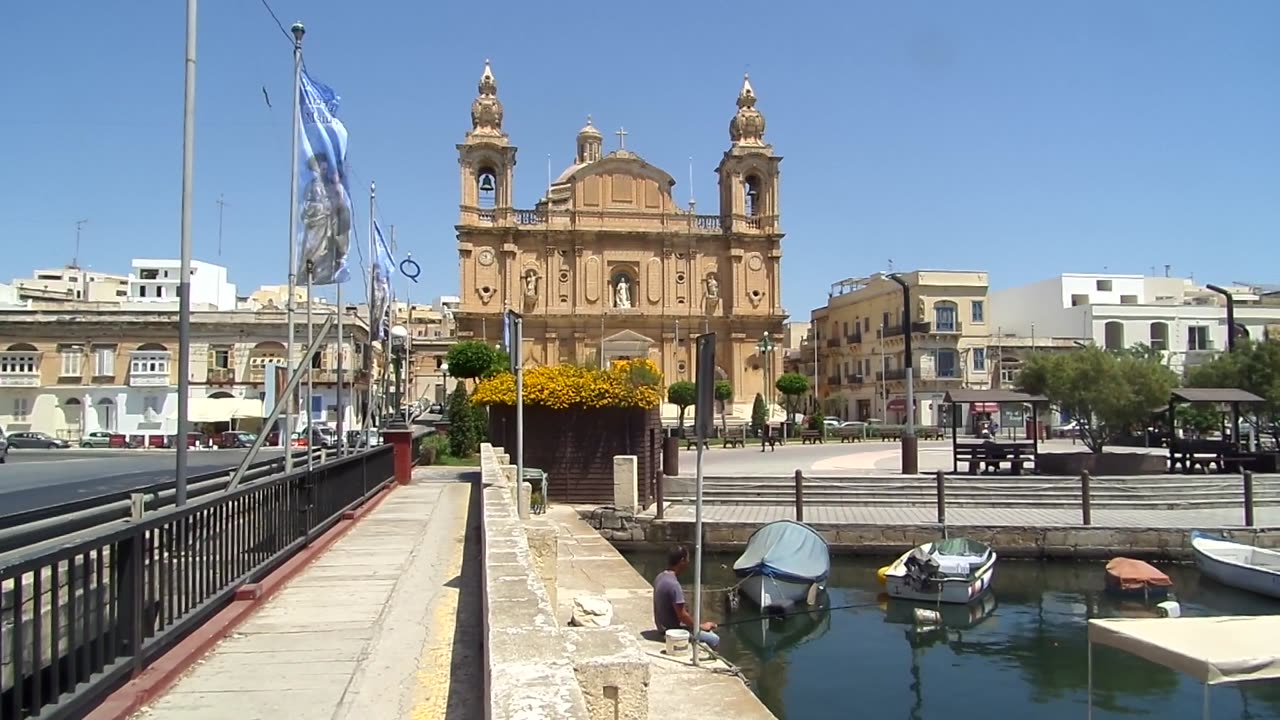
(1187, 340, 1280, 442)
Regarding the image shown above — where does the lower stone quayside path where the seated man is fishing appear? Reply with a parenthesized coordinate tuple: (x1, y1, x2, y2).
(545, 505, 774, 720)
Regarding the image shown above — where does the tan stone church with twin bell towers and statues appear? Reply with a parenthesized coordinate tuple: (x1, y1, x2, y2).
(457, 61, 786, 414)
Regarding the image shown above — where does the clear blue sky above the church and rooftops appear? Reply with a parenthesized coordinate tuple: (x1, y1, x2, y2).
(0, 0, 1280, 313)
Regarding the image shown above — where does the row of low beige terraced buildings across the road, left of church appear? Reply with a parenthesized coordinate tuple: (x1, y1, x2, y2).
(0, 306, 381, 442)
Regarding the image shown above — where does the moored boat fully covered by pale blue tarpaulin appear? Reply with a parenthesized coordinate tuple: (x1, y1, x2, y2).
(733, 520, 831, 612)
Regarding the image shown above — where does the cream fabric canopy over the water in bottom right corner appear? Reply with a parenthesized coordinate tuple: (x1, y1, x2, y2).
(1089, 615, 1280, 685)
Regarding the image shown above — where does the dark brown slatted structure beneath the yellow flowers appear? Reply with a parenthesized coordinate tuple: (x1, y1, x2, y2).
(489, 406, 662, 506)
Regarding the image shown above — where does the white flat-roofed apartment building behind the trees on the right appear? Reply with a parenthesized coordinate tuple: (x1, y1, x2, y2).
(991, 273, 1280, 372)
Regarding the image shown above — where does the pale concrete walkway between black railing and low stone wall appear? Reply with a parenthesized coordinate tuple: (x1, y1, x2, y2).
(136, 468, 484, 720)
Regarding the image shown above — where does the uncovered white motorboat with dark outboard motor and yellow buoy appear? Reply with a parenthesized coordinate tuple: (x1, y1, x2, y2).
(877, 538, 996, 605)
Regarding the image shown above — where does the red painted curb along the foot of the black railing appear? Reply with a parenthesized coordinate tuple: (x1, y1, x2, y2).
(84, 483, 397, 720)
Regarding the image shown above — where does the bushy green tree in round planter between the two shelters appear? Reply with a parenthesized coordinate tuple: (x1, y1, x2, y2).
(1018, 346, 1178, 452)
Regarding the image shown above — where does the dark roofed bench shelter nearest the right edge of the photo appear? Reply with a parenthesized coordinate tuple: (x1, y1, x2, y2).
(1169, 387, 1276, 473)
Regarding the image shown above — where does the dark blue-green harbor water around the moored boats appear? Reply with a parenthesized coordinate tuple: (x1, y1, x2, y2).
(628, 552, 1280, 720)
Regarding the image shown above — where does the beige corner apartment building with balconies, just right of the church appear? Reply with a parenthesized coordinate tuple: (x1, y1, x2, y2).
(797, 270, 993, 425)
